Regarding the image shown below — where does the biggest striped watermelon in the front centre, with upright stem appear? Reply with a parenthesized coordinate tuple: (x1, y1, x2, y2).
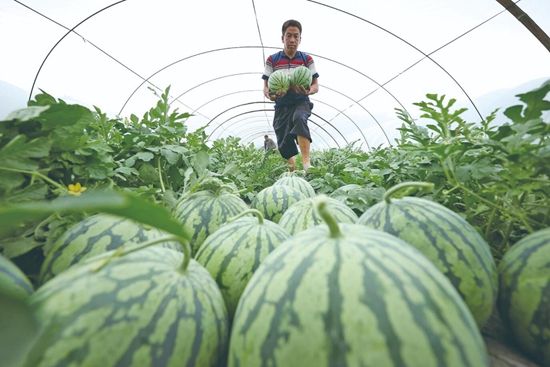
(229, 200, 489, 367)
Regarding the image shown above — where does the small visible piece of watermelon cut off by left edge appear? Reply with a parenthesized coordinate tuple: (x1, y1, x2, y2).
(0, 255, 34, 301)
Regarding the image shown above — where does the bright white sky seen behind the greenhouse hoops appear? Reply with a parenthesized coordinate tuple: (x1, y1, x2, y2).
(0, 0, 550, 149)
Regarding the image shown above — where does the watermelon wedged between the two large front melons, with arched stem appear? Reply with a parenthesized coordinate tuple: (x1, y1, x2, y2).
(195, 209, 290, 321)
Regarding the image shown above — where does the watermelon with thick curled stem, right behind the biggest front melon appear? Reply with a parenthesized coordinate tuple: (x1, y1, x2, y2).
(357, 183, 498, 328)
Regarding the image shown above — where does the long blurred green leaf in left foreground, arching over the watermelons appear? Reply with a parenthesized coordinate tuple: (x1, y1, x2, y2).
(0, 191, 191, 241)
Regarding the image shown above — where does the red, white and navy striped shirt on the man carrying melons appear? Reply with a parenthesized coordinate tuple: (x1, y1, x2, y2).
(262, 51, 319, 108)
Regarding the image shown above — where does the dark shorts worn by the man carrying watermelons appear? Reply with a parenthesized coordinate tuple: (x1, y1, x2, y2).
(273, 101, 313, 159)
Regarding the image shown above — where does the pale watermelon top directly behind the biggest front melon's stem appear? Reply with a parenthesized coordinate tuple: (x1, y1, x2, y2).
(279, 196, 358, 235)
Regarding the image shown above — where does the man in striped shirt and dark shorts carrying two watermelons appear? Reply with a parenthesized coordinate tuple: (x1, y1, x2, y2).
(262, 19, 319, 172)
